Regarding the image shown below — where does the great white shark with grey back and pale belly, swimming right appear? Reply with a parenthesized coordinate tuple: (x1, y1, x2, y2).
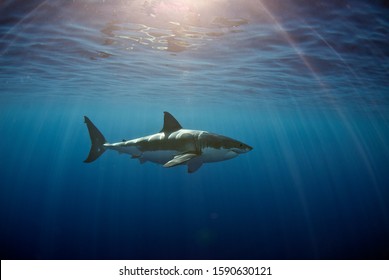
(84, 112, 253, 173)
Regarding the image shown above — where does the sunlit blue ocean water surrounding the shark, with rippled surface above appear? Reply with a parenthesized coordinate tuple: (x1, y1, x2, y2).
(0, 0, 389, 259)
